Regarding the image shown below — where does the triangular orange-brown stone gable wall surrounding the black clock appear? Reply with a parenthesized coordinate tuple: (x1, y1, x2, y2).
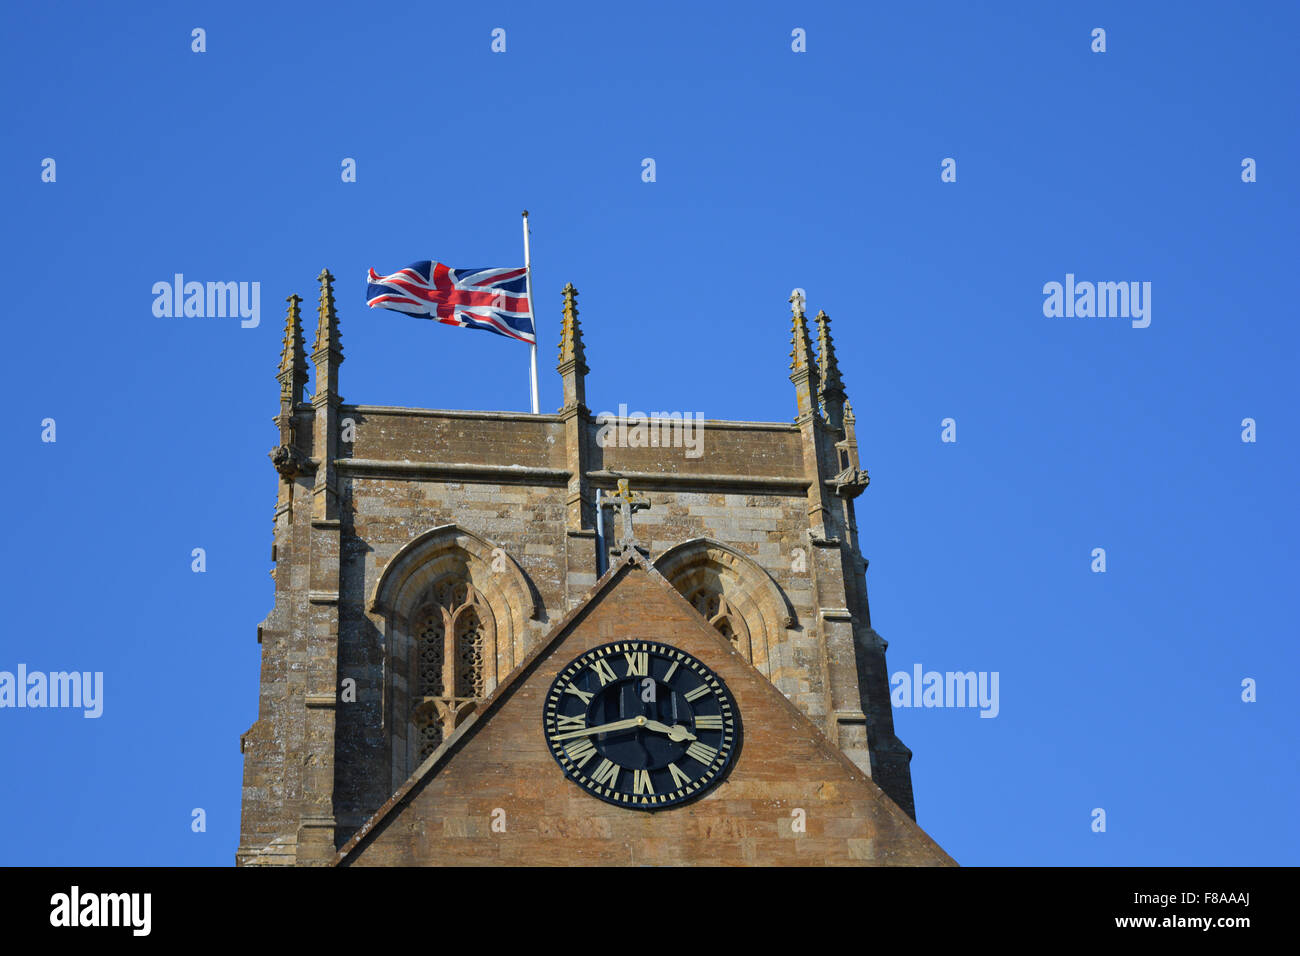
(335, 554, 953, 866)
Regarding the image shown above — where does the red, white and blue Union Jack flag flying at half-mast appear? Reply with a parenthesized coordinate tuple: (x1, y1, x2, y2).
(365, 260, 537, 345)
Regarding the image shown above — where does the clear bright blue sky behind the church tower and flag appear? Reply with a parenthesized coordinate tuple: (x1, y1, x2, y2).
(0, 3, 1300, 865)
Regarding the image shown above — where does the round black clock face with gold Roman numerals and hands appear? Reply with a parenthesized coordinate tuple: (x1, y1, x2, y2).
(542, 641, 740, 810)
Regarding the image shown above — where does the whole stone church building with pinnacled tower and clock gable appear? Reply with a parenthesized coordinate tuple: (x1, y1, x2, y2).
(237, 271, 952, 865)
